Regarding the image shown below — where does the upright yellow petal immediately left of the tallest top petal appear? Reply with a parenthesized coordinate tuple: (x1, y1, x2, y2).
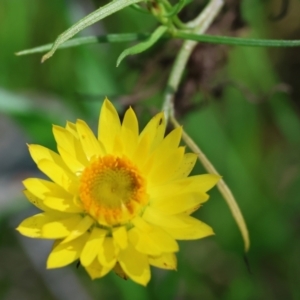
(76, 120, 105, 160)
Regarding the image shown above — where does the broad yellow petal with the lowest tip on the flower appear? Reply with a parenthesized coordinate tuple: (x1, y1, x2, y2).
(118, 244, 151, 286)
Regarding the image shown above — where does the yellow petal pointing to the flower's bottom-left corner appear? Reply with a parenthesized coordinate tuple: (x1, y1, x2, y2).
(47, 233, 88, 269)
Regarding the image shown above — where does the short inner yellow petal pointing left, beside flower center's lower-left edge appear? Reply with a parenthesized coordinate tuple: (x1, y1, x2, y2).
(44, 195, 83, 213)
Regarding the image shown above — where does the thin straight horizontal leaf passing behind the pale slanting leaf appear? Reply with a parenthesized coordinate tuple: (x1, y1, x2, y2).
(16, 33, 150, 55)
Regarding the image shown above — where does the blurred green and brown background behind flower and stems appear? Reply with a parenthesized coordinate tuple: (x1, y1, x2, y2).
(0, 0, 300, 300)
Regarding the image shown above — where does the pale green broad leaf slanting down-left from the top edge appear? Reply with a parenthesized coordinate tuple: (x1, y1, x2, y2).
(42, 0, 143, 63)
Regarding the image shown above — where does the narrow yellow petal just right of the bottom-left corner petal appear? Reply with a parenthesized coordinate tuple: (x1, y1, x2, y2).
(80, 226, 107, 269)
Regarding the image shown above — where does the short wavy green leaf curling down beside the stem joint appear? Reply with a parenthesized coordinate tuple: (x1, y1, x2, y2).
(117, 26, 168, 67)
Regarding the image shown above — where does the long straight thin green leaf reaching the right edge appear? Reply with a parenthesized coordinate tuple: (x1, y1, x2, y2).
(174, 31, 300, 47)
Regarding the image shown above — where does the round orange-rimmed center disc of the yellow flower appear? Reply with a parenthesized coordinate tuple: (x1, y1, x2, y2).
(79, 155, 148, 226)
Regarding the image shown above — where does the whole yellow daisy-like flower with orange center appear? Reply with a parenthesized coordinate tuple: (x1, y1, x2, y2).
(17, 99, 219, 285)
